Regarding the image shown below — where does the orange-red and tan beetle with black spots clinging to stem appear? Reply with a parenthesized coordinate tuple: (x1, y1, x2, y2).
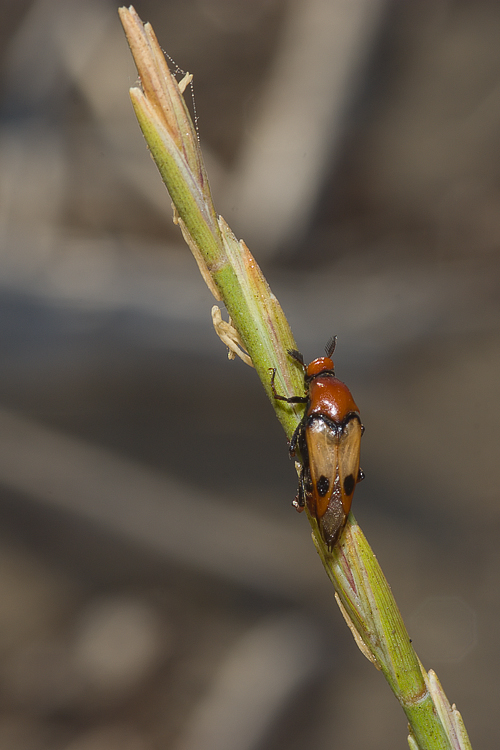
(271, 336, 365, 551)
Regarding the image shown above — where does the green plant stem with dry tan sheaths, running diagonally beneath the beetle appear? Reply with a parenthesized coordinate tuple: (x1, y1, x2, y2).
(119, 7, 470, 750)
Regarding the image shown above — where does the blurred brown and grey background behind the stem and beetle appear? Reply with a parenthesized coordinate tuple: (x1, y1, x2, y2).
(0, 0, 500, 750)
